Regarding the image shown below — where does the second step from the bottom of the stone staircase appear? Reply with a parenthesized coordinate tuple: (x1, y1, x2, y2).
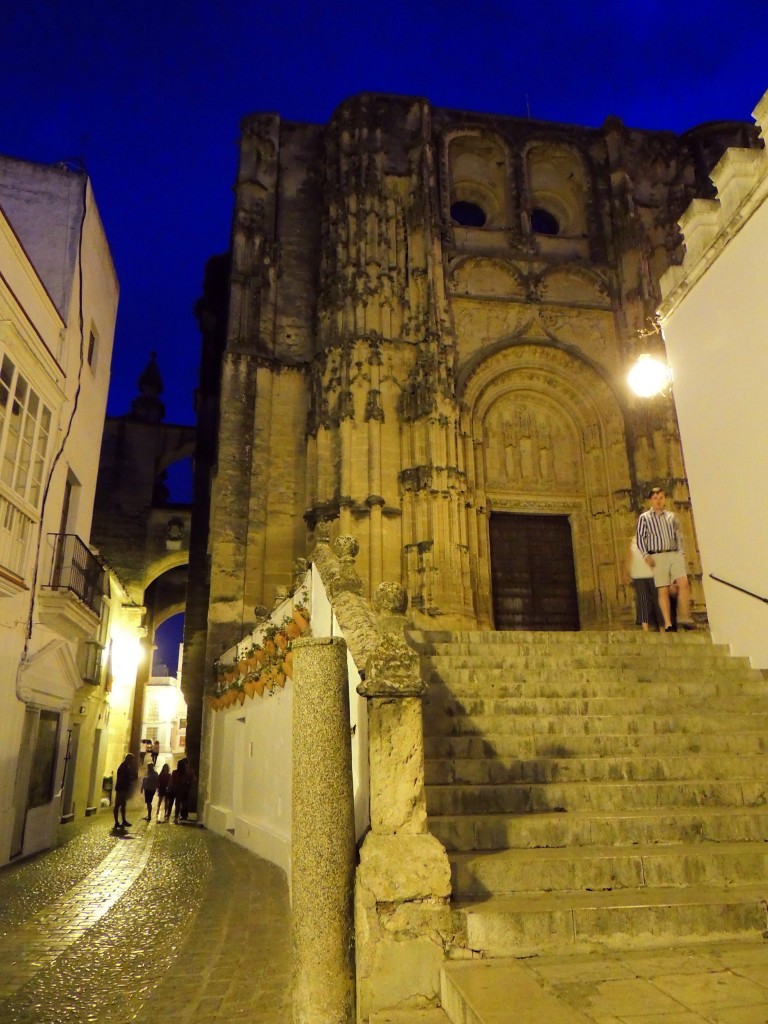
(450, 843, 768, 898)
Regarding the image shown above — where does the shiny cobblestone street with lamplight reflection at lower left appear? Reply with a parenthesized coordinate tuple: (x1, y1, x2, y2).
(0, 801, 291, 1024)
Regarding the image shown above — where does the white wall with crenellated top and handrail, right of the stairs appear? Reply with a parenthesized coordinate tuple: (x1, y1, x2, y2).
(659, 86, 768, 668)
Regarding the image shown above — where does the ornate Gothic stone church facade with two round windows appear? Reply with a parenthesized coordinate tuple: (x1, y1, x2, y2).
(199, 94, 760, 659)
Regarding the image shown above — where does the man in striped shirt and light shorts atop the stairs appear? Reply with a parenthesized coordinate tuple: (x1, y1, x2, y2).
(636, 487, 696, 633)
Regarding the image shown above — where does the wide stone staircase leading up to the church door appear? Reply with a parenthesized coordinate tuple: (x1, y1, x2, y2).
(411, 631, 768, 1020)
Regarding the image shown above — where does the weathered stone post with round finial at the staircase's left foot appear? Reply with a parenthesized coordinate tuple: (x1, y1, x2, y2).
(355, 584, 452, 1021)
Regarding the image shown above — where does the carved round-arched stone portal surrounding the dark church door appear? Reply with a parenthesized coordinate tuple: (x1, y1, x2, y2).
(462, 342, 634, 628)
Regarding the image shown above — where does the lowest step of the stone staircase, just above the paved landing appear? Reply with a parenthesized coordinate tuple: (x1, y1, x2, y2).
(457, 884, 766, 956)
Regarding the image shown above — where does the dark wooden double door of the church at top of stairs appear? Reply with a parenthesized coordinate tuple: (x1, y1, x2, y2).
(489, 512, 579, 630)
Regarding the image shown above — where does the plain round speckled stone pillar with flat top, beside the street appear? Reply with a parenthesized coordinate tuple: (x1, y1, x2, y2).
(291, 637, 355, 1024)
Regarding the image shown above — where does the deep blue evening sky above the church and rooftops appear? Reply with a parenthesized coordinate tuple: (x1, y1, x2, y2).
(0, 0, 768, 422)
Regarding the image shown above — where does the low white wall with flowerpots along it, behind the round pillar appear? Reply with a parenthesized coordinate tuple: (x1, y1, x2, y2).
(204, 569, 370, 878)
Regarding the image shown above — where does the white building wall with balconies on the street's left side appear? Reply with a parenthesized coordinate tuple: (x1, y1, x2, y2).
(0, 158, 118, 863)
